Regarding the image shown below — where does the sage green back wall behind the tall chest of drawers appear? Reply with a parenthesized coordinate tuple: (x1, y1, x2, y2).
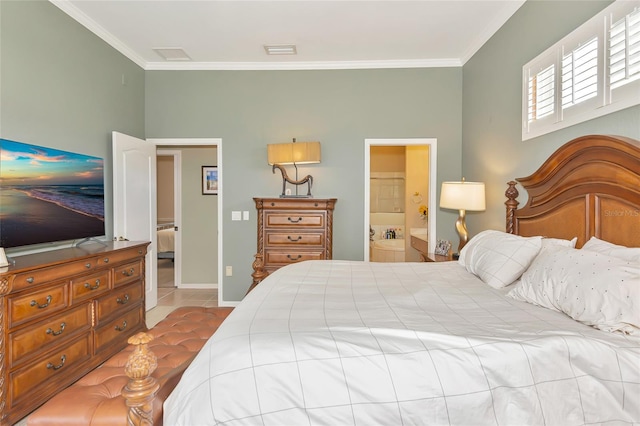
(145, 68, 462, 301)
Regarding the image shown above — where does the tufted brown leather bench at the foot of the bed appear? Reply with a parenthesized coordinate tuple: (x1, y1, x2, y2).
(27, 307, 233, 426)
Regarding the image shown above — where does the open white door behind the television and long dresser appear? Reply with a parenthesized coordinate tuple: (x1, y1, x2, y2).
(112, 132, 158, 310)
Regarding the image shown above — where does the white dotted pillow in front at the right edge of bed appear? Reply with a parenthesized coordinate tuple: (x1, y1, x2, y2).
(508, 246, 640, 334)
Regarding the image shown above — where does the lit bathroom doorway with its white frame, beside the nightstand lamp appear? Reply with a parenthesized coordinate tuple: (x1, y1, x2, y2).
(364, 138, 437, 262)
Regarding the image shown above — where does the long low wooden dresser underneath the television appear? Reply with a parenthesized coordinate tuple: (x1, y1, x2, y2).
(0, 241, 148, 425)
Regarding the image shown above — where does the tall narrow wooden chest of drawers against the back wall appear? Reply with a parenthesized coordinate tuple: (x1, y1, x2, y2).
(249, 198, 336, 291)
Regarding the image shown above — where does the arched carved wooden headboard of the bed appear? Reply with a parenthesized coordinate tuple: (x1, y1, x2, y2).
(505, 135, 640, 247)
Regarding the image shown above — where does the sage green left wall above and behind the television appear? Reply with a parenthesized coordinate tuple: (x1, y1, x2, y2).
(0, 0, 144, 243)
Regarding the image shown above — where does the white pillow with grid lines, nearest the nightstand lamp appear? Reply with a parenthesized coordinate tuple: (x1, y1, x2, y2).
(458, 230, 542, 288)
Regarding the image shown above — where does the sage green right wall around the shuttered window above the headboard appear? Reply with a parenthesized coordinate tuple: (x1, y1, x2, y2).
(462, 0, 640, 235)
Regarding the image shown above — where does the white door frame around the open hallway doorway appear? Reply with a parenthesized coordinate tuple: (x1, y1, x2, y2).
(147, 138, 224, 306)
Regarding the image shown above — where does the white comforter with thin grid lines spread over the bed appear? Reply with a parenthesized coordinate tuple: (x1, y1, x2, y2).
(164, 261, 640, 426)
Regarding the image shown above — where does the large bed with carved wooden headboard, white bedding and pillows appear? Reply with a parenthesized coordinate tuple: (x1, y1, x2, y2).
(164, 136, 640, 426)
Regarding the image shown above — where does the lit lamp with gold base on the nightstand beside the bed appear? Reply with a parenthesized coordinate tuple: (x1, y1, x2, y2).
(440, 178, 486, 258)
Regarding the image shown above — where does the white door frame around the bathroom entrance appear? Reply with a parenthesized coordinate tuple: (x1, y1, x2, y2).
(363, 138, 438, 262)
